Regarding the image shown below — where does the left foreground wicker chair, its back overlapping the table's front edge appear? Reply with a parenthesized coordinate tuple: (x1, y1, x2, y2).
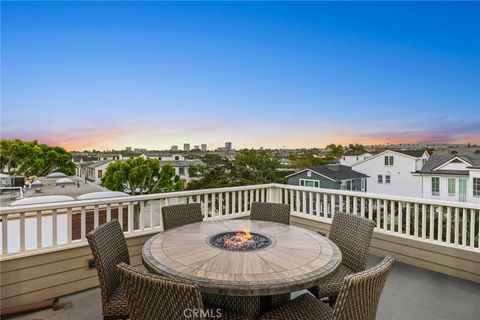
(117, 263, 251, 320)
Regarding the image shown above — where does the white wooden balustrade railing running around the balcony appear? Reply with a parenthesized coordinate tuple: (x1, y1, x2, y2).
(0, 184, 480, 260)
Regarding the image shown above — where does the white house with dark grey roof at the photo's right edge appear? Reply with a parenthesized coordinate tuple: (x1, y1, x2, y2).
(418, 155, 480, 203)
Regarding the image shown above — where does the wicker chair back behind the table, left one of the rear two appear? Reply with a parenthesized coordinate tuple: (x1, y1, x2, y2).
(162, 203, 203, 231)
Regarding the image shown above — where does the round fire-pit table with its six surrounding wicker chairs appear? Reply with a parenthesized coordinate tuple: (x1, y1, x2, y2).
(87, 202, 395, 320)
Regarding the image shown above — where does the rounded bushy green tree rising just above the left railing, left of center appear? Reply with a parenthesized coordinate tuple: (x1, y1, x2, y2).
(102, 157, 183, 195)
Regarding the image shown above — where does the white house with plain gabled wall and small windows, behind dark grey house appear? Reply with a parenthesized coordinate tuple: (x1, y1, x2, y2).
(352, 150, 429, 198)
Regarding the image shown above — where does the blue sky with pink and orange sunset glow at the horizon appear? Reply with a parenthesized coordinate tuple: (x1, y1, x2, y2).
(1, 2, 480, 150)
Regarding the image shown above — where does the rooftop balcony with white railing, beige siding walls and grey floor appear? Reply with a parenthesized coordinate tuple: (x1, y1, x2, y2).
(0, 184, 480, 319)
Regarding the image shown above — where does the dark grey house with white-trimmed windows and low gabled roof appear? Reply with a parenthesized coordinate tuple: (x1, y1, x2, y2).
(286, 164, 368, 191)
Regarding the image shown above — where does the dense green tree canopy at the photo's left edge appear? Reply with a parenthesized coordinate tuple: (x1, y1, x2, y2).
(0, 139, 75, 176)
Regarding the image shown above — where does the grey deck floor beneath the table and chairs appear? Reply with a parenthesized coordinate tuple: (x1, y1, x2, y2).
(8, 256, 480, 320)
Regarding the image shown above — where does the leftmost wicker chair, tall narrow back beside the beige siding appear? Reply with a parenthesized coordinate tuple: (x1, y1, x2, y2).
(87, 220, 130, 319)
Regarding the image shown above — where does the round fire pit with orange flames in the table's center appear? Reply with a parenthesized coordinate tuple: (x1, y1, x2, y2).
(207, 230, 272, 251)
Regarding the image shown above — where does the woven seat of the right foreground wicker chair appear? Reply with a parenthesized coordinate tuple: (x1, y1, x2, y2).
(260, 293, 333, 320)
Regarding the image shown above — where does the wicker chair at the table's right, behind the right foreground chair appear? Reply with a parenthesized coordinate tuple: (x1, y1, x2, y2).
(308, 212, 375, 303)
